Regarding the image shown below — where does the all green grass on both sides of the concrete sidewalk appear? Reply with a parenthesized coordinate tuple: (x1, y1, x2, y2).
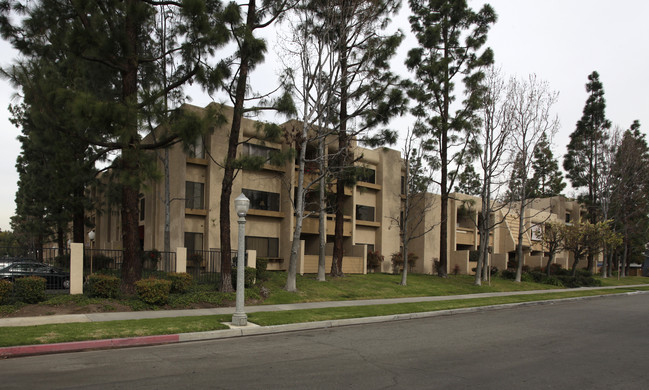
(0, 273, 649, 347)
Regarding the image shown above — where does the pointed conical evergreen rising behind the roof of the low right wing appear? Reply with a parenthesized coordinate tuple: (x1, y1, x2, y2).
(530, 133, 566, 198)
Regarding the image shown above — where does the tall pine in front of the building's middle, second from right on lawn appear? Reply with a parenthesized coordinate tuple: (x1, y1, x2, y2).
(313, 0, 403, 276)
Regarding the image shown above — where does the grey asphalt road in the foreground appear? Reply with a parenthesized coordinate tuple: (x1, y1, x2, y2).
(0, 294, 649, 390)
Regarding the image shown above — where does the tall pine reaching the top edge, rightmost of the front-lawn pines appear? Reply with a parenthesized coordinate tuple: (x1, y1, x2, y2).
(406, 0, 496, 276)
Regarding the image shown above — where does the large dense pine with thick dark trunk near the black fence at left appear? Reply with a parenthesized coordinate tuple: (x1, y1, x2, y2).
(0, 0, 233, 292)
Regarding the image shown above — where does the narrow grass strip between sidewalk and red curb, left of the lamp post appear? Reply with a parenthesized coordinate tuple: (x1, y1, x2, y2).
(0, 316, 231, 347)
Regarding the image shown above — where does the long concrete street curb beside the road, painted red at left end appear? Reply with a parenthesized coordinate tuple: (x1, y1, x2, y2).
(0, 291, 649, 359)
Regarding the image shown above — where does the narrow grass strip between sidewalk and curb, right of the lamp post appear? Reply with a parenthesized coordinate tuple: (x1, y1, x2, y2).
(248, 287, 649, 326)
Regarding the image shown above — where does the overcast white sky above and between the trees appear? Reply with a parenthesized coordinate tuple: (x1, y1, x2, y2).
(0, 0, 649, 230)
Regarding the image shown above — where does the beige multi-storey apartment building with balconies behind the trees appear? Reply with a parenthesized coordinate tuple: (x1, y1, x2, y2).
(93, 105, 583, 274)
